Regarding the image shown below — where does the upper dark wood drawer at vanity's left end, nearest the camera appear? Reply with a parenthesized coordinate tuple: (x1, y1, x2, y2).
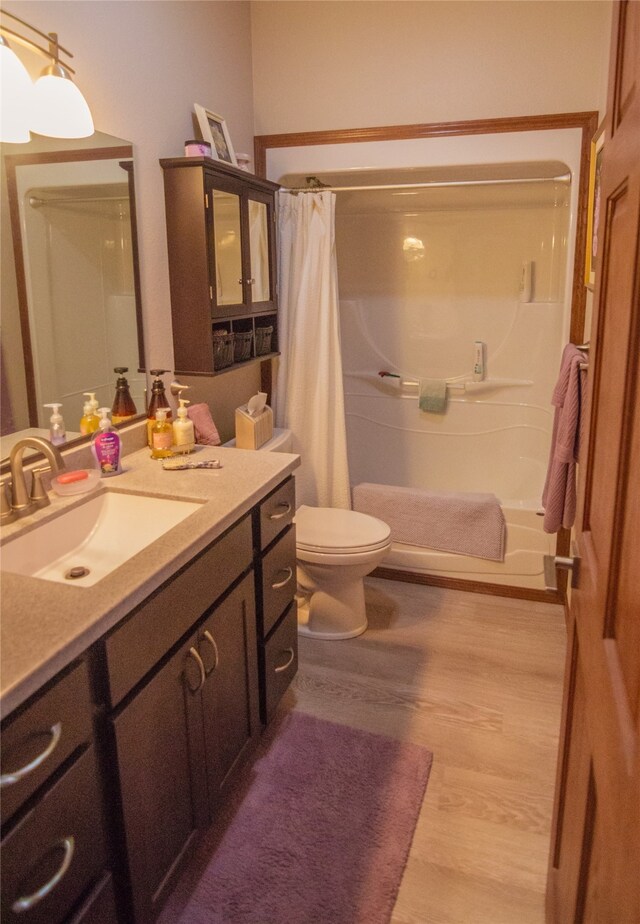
(0, 661, 92, 824)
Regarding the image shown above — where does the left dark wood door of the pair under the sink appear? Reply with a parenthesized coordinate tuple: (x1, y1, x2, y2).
(112, 636, 207, 924)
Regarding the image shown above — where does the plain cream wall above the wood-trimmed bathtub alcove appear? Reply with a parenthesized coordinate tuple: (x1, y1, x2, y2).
(251, 0, 611, 134)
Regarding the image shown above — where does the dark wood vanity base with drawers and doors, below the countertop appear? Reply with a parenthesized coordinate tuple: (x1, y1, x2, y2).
(2, 478, 297, 924)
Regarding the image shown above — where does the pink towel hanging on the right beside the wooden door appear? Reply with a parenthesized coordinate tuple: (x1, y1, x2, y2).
(542, 343, 586, 533)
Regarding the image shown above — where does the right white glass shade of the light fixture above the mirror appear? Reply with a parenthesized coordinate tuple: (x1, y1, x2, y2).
(31, 65, 94, 138)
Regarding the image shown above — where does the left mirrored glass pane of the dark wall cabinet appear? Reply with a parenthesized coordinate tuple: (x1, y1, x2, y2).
(212, 189, 243, 307)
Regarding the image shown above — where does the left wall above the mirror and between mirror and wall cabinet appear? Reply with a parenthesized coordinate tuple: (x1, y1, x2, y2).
(9, 0, 258, 436)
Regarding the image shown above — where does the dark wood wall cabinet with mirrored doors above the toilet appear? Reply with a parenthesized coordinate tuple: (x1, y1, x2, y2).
(160, 157, 278, 375)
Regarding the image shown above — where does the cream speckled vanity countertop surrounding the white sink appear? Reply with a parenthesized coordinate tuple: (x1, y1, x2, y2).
(0, 446, 300, 718)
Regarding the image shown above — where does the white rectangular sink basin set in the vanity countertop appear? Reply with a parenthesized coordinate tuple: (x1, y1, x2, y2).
(0, 491, 201, 587)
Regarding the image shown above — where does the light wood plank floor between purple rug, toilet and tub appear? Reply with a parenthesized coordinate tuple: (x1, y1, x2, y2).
(283, 578, 566, 924)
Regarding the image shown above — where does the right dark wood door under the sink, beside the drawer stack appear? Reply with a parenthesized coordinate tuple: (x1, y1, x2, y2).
(198, 574, 260, 818)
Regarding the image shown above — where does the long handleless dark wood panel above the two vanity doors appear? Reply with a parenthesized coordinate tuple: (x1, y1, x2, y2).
(104, 516, 252, 706)
